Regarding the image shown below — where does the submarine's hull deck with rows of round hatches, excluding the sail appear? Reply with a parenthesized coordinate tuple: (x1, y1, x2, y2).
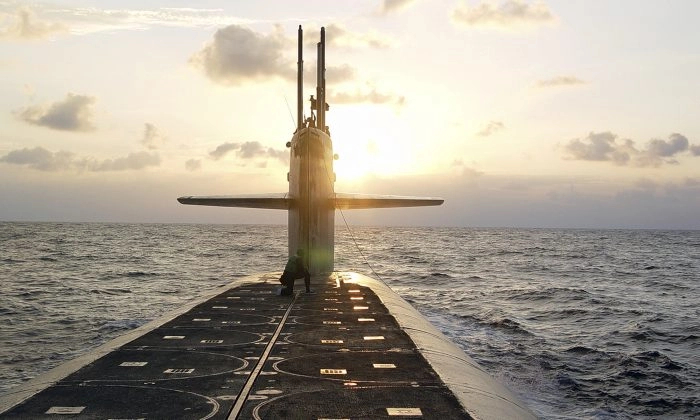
(0, 273, 532, 419)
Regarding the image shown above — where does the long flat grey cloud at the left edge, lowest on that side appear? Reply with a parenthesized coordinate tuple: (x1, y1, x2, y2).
(0, 147, 160, 172)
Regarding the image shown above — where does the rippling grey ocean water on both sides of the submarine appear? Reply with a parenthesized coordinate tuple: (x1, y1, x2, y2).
(0, 222, 700, 419)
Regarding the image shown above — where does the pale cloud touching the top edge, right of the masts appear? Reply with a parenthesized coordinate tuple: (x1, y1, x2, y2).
(452, 0, 556, 28)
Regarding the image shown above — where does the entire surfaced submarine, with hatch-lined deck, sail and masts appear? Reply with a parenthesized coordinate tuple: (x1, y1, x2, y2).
(0, 26, 536, 420)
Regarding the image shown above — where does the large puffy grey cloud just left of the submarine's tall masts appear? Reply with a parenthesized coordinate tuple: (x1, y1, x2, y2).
(190, 25, 296, 86)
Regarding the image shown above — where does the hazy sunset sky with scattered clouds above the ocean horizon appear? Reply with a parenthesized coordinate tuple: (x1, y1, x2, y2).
(0, 0, 700, 229)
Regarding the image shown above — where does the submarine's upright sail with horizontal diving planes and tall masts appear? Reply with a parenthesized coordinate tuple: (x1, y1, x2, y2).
(178, 26, 444, 275)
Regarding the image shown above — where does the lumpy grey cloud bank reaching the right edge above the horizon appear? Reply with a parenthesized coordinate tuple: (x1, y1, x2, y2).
(564, 131, 698, 167)
